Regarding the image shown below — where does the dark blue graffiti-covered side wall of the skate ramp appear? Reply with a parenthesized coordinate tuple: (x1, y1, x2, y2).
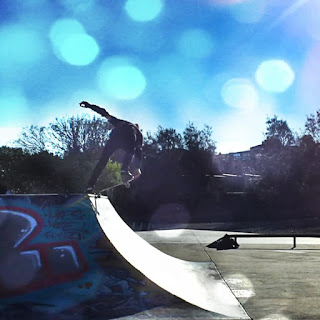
(0, 194, 176, 320)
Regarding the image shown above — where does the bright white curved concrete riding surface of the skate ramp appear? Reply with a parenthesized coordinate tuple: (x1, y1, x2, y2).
(89, 195, 250, 319)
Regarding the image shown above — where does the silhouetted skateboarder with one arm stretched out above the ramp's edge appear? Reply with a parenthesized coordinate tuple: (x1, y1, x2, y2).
(80, 101, 143, 193)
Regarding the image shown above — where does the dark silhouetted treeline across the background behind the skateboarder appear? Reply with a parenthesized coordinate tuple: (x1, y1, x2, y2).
(0, 111, 320, 224)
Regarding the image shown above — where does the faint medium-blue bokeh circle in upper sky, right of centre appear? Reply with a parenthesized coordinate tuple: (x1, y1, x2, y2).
(178, 29, 214, 58)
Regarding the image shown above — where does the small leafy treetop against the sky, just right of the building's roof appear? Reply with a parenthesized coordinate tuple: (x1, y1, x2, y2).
(264, 116, 295, 146)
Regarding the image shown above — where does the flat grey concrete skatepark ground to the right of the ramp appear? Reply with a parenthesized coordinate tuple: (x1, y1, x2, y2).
(138, 229, 320, 320)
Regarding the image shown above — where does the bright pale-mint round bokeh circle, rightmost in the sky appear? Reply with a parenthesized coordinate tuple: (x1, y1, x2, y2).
(255, 60, 295, 93)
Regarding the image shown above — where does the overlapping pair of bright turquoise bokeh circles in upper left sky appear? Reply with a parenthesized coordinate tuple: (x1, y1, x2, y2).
(49, 19, 100, 66)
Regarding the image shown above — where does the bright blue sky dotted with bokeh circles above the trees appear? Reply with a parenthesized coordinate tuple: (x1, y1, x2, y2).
(0, 0, 320, 152)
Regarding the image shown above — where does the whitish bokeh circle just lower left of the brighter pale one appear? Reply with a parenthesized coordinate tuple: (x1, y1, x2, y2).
(221, 78, 259, 110)
